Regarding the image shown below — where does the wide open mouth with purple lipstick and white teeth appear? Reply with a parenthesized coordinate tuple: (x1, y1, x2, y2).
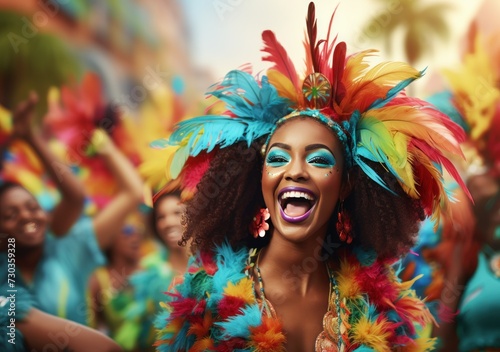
(278, 187, 316, 222)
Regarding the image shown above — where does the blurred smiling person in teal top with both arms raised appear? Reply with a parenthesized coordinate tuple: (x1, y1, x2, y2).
(0, 95, 143, 324)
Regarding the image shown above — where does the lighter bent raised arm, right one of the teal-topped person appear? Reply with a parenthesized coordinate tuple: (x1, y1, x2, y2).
(92, 130, 144, 249)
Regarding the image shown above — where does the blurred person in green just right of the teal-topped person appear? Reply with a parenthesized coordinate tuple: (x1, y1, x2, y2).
(88, 209, 154, 351)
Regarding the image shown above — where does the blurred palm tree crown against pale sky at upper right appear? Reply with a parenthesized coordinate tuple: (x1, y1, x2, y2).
(361, 0, 453, 65)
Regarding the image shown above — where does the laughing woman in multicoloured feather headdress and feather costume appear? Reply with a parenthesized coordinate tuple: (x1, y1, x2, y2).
(156, 3, 470, 352)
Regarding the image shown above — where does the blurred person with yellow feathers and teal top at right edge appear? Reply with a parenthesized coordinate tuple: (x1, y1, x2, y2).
(428, 20, 500, 352)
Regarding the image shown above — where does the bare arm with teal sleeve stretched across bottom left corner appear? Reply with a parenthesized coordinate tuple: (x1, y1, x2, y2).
(0, 283, 121, 352)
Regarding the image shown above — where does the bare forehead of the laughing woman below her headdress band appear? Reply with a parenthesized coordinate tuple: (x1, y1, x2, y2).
(269, 116, 342, 150)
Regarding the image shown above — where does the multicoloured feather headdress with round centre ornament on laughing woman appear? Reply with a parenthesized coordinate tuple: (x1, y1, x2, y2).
(156, 3, 465, 223)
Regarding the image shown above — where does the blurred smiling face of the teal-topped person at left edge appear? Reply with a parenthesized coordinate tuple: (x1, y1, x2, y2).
(0, 187, 48, 248)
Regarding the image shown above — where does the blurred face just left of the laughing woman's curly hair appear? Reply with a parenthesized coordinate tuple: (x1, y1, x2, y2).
(155, 196, 185, 248)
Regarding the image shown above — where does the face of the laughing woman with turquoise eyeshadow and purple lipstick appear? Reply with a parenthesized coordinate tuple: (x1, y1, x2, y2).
(262, 117, 344, 242)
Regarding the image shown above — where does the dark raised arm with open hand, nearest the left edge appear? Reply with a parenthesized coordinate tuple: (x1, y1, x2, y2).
(11, 93, 85, 236)
